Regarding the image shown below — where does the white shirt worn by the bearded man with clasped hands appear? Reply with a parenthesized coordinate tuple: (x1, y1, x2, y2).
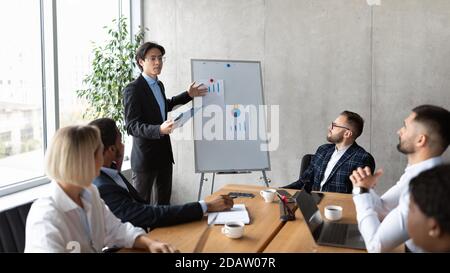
(353, 157, 443, 252)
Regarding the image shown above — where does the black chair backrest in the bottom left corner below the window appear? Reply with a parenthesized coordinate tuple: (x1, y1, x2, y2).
(0, 202, 33, 253)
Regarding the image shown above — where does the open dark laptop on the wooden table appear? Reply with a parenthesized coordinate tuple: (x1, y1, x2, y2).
(296, 190, 366, 249)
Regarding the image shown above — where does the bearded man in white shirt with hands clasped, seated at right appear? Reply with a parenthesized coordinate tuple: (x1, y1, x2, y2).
(350, 105, 450, 252)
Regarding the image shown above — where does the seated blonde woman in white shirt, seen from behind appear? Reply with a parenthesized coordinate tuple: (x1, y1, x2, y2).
(25, 126, 176, 252)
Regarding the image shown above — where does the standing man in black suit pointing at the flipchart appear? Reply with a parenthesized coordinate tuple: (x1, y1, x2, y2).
(123, 42, 207, 205)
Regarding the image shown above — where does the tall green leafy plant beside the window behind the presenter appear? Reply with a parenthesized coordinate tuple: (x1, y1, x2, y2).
(76, 17, 145, 134)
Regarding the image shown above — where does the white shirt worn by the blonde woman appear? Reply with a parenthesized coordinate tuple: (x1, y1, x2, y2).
(25, 181, 145, 252)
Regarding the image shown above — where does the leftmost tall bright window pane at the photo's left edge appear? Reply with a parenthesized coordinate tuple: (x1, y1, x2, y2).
(0, 0, 44, 188)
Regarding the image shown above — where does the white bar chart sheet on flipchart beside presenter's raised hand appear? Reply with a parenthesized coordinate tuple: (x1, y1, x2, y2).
(194, 79, 225, 107)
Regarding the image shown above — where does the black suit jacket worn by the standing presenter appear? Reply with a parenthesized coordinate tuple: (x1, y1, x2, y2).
(123, 75, 192, 172)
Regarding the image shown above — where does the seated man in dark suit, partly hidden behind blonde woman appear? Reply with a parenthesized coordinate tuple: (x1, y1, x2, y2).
(90, 118, 233, 229)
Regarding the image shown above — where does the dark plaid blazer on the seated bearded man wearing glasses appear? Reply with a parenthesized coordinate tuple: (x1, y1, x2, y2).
(284, 142, 375, 193)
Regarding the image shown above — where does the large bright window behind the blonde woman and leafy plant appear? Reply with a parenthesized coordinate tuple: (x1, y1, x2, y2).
(0, 0, 141, 196)
